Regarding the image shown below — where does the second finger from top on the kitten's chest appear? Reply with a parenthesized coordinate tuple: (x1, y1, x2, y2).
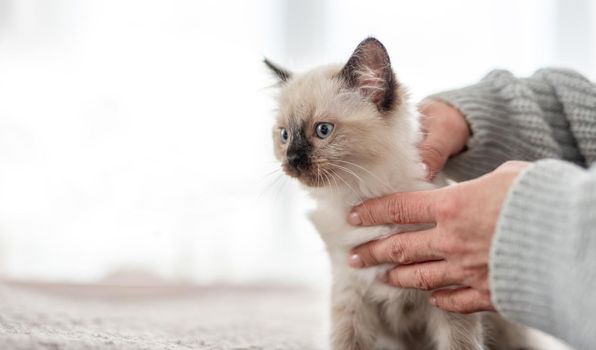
(349, 229, 442, 268)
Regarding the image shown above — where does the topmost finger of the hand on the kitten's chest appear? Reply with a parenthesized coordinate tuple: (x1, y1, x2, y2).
(348, 190, 440, 226)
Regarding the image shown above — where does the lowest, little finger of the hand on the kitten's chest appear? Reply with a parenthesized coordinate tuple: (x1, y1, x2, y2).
(430, 288, 495, 314)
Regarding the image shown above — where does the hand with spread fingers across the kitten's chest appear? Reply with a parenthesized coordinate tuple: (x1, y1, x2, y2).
(348, 162, 530, 313)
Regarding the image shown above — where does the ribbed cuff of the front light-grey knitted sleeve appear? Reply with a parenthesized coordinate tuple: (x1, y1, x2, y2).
(489, 160, 582, 336)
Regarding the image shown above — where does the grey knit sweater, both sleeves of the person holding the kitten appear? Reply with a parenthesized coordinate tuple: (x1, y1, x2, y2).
(435, 69, 596, 349)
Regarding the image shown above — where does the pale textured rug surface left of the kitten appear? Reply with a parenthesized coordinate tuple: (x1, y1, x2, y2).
(0, 284, 327, 350)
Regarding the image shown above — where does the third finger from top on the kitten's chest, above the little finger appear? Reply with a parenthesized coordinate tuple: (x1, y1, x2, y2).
(387, 260, 463, 290)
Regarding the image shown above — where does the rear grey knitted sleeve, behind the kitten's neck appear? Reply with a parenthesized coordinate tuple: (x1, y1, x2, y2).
(431, 69, 596, 181)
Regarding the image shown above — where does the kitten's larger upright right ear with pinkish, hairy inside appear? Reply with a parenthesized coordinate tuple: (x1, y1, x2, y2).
(340, 38, 398, 112)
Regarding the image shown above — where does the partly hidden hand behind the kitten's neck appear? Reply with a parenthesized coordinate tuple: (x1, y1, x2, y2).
(418, 100, 470, 180)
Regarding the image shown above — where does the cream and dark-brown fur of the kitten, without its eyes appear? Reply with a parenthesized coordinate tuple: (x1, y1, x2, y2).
(265, 38, 523, 350)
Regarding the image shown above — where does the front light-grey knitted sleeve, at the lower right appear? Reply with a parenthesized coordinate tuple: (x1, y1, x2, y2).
(489, 160, 596, 350)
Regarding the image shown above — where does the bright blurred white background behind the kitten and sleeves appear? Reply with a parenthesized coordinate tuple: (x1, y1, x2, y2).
(0, 0, 596, 284)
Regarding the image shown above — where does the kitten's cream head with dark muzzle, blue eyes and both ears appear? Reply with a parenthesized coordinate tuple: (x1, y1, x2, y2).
(265, 38, 412, 187)
